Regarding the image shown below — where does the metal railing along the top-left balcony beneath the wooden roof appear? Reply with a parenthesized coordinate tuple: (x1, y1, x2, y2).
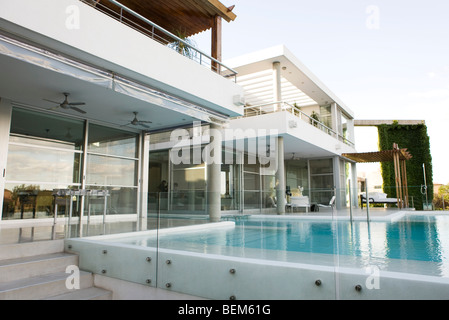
(80, 0, 237, 82)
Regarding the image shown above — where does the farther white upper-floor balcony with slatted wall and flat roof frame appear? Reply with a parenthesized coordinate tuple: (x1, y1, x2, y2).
(227, 46, 354, 157)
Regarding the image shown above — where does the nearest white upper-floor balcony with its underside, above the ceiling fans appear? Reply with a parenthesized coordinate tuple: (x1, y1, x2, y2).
(0, 0, 243, 130)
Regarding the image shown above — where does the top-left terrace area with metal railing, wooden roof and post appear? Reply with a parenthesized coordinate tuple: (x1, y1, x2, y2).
(80, 0, 237, 81)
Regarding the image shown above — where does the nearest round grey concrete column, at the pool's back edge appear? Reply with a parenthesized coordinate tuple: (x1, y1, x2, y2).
(203, 124, 223, 222)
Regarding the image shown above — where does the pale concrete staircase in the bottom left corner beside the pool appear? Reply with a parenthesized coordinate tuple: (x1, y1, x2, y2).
(0, 240, 112, 300)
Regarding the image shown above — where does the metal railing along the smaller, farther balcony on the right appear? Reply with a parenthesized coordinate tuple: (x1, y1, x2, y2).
(243, 101, 354, 146)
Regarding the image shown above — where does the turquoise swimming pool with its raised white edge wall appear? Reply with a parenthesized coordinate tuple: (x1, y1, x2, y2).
(66, 214, 449, 299)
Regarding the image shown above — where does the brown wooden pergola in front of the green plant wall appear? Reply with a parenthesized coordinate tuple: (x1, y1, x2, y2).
(342, 143, 412, 209)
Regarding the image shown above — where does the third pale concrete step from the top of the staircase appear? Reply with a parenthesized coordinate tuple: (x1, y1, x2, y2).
(0, 271, 93, 300)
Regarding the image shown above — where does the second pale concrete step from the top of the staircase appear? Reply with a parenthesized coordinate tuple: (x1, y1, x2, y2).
(0, 252, 78, 283)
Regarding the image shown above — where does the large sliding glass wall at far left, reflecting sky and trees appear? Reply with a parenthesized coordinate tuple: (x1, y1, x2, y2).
(2, 108, 138, 220)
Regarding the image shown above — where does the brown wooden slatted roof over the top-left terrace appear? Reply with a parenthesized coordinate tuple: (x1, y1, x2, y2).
(99, 0, 236, 37)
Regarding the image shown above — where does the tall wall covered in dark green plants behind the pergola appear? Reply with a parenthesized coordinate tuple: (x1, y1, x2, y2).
(377, 122, 433, 210)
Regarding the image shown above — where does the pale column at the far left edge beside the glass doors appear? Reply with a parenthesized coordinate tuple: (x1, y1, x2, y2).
(0, 97, 12, 221)
